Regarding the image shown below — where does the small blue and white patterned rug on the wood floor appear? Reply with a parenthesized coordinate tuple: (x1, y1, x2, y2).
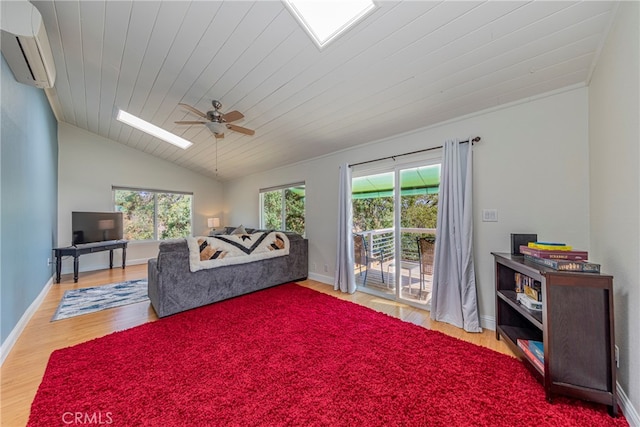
(51, 279, 149, 322)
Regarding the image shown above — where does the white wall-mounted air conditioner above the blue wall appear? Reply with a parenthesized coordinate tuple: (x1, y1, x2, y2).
(0, 0, 56, 88)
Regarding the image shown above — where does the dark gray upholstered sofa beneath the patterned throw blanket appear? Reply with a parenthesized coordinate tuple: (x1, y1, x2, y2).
(147, 233, 309, 317)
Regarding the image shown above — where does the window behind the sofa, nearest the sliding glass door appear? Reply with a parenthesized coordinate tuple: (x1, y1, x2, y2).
(260, 182, 305, 235)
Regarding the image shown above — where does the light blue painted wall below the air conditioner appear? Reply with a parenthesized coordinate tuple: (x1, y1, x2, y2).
(0, 57, 58, 343)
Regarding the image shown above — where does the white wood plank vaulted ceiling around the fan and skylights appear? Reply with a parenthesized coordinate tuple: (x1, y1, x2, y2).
(33, 0, 617, 181)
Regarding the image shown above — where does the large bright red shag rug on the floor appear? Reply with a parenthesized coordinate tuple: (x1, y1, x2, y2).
(29, 284, 628, 427)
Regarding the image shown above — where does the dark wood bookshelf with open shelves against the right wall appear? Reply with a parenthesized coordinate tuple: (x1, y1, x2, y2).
(492, 252, 618, 416)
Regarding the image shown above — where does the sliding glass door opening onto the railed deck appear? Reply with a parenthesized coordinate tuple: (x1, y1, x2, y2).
(352, 162, 440, 306)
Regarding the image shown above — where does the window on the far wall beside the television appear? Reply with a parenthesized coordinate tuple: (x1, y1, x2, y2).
(113, 187, 193, 240)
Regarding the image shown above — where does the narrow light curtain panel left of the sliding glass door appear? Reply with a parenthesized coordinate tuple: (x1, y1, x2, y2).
(333, 163, 356, 294)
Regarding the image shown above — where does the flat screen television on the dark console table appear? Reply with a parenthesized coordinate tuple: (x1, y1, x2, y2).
(71, 212, 123, 246)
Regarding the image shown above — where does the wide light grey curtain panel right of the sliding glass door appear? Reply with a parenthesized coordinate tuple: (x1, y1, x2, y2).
(431, 139, 482, 332)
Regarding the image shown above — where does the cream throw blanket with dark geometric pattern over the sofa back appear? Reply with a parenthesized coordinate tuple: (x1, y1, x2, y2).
(187, 231, 289, 272)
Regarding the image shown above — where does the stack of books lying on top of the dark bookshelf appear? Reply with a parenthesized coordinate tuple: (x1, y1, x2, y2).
(520, 242, 600, 273)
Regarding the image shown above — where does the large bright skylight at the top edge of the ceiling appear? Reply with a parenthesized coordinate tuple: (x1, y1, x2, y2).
(283, 0, 375, 49)
